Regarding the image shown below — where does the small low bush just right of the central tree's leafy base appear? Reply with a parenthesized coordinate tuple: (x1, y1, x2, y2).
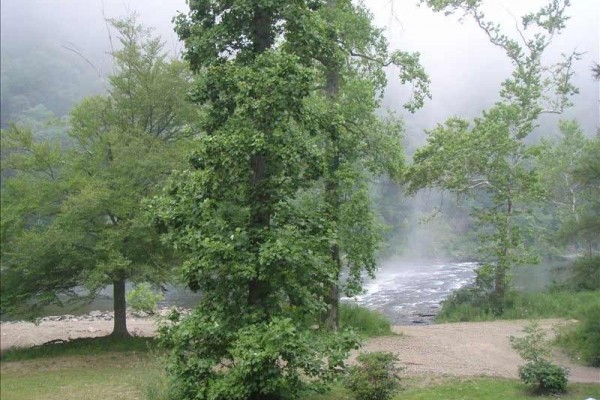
(346, 351, 400, 400)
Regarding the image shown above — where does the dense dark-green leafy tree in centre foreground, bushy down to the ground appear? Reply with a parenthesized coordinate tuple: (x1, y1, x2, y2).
(153, 0, 366, 399)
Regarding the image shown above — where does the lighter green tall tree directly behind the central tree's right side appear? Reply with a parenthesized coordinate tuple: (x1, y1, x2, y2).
(287, 0, 429, 329)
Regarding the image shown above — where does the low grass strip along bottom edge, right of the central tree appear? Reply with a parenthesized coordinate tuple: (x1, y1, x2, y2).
(304, 378, 600, 400)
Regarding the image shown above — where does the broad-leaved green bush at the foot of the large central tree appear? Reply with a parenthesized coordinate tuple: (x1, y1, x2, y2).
(159, 314, 358, 400)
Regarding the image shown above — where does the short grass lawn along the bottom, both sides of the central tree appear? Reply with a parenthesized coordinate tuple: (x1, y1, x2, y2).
(0, 351, 600, 400)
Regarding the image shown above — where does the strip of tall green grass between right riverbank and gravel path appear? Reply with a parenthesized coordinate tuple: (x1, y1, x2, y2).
(436, 291, 600, 322)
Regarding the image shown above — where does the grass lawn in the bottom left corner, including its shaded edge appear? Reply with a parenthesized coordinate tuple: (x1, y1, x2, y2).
(0, 337, 158, 400)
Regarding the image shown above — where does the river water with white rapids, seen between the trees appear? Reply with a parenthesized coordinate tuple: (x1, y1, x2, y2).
(2, 258, 564, 325)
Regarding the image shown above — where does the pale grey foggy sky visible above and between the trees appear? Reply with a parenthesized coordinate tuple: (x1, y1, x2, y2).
(1, 0, 600, 135)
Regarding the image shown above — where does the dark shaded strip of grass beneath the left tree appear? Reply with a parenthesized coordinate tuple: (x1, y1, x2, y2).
(1, 336, 157, 362)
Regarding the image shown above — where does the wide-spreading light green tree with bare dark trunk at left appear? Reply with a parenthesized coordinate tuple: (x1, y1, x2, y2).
(2, 18, 192, 336)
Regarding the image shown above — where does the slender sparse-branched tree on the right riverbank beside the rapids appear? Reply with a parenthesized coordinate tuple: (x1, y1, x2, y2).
(411, 0, 578, 312)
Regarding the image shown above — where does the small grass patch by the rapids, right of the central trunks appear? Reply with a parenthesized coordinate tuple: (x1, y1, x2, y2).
(340, 303, 394, 337)
